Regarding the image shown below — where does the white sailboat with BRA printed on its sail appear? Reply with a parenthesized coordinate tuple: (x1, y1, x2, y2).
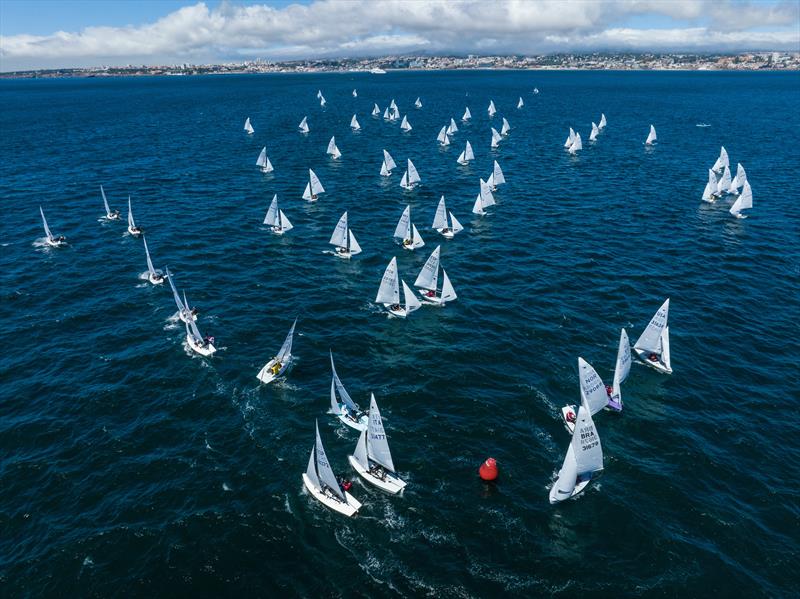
(550, 366, 603, 504)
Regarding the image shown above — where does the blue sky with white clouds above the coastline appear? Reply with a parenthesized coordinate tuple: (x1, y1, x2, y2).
(0, 0, 800, 71)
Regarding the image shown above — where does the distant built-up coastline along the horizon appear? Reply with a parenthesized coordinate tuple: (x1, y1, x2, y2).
(0, 52, 800, 79)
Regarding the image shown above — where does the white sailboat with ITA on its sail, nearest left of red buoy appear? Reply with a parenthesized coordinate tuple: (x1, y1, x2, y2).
(347, 394, 406, 495)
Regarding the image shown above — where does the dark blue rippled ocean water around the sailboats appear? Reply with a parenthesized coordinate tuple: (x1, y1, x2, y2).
(0, 72, 800, 597)
